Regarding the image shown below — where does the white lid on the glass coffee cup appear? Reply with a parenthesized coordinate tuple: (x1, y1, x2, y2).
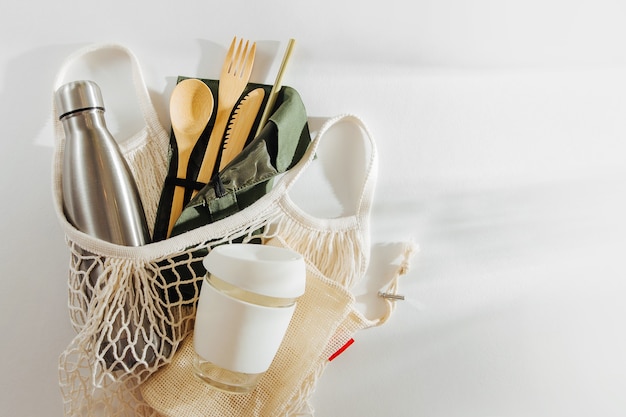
(203, 243, 306, 298)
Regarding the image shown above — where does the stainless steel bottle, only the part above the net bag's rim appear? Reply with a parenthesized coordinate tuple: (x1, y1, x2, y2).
(56, 81, 150, 246)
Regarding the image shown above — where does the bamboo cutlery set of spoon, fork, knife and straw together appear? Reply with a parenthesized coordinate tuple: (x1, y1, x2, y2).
(161, 38, 294, 237)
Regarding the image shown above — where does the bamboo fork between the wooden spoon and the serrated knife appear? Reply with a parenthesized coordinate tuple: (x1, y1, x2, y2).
(198, 37, 256, 190)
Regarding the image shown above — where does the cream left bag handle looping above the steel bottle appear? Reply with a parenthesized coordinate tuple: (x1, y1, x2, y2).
(52, 43, 165, 143)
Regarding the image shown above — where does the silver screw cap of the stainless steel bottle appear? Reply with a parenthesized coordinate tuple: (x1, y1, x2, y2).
(55, 80, 104, 118)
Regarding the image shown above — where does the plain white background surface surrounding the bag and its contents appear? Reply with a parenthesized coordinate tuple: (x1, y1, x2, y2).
(0, 0, 626, 417)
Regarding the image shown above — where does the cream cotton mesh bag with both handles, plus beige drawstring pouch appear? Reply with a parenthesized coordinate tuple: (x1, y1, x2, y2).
(53, 45, 413, 417)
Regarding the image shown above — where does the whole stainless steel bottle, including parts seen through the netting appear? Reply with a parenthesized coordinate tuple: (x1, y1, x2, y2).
(55, 81, 155, 370)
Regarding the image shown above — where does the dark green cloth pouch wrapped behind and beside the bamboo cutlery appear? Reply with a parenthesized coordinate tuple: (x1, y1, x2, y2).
(153, 77, 311, 303)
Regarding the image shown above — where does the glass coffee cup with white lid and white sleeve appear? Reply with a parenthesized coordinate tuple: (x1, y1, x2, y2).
(193, 244, 306, 393)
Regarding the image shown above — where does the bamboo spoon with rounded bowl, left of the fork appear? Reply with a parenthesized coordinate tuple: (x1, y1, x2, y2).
(167, 78, 213, 237)
